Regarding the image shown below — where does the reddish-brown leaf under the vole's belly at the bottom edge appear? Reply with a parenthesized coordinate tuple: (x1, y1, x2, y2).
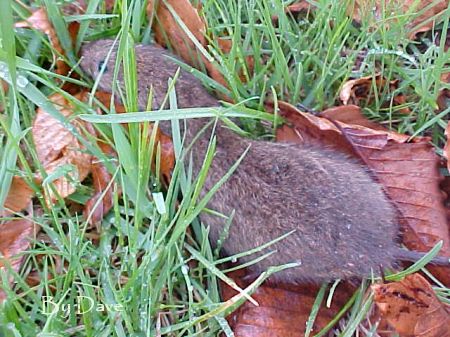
(222, 270, 354, 337)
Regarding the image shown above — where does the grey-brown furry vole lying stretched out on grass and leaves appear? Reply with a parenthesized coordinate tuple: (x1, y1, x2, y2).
(81, 40, 442, 282)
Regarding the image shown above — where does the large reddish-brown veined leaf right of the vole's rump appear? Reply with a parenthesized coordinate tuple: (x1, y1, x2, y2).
(343, 127, 450, 284)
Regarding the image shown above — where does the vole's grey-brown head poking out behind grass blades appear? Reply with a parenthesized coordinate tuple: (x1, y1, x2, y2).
(80, 40, 117, 91)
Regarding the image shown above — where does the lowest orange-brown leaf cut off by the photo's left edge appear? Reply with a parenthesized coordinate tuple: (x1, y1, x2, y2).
(0, 219, 33, 304)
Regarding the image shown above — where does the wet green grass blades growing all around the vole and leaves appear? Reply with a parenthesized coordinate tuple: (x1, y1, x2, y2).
(0, 0, 450, 337)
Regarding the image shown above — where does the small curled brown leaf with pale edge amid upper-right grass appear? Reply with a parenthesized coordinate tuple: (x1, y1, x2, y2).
(339, 75, 410, 114)
